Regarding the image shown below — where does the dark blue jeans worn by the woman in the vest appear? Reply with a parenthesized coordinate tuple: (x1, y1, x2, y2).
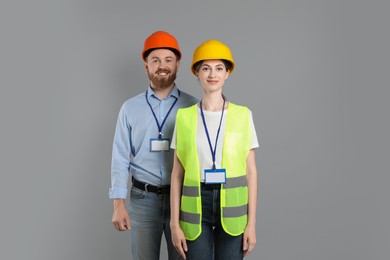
(186, 188, 244, 260)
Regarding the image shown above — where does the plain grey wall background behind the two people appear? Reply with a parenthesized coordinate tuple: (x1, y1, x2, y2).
(0, 0, 390, 260)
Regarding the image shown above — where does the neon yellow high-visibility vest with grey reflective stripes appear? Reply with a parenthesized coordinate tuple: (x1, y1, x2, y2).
(176, 103, 252, 240)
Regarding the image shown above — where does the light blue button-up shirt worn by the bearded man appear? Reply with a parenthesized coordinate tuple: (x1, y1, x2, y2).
(109, 86, 198, 199)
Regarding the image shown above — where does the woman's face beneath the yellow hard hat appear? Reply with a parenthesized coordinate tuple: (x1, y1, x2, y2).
(197, 60, 229, 92)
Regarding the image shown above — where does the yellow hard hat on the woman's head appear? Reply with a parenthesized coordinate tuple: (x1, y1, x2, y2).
(191, 40, 234, 75)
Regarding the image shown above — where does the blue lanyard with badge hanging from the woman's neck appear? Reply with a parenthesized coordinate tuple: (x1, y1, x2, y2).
(199, 98, 226, 184)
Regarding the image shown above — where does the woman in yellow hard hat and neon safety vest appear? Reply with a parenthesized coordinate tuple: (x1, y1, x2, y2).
(170, 40, 259, 260)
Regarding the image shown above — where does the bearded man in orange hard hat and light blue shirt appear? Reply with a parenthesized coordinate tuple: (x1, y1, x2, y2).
(109, 31, 198, 260)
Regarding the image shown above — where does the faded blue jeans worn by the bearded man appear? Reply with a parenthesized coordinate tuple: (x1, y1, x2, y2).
(129, 187, 181, 260)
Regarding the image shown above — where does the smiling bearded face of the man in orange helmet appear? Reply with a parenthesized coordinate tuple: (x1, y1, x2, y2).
(144, 49, 180, 90)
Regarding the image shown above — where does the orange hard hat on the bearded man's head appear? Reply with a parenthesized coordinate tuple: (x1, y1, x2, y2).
(142, 31, 181, 60)
